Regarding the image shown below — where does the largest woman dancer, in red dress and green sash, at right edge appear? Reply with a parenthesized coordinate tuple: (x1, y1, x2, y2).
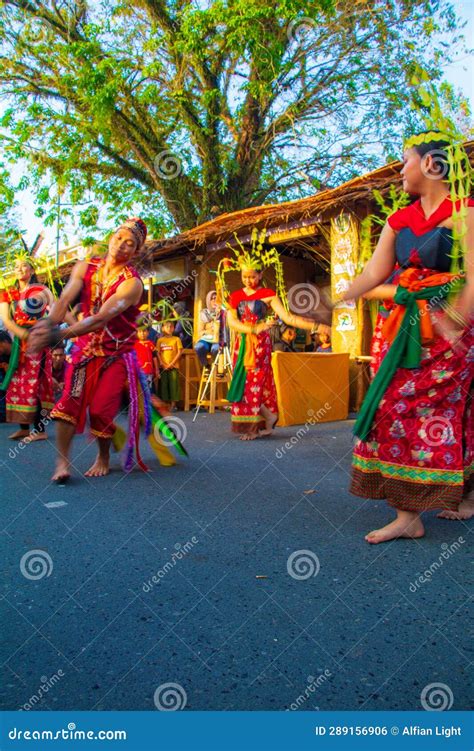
(344, 132, 474, 544)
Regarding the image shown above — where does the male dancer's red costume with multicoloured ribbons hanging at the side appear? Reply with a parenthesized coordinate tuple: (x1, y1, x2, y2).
(51, 258, 186, 471)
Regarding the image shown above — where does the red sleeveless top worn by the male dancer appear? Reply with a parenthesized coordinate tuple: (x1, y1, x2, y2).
(80, 257, 141, 357)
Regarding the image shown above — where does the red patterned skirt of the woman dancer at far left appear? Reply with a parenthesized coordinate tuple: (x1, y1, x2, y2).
(6, 349, 53, 424)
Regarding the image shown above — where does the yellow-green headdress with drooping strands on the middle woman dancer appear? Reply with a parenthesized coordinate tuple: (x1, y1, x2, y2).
(216, 227, 289, 311)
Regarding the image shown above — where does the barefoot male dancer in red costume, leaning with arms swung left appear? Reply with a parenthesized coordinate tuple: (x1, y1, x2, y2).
(29, 218, 147, 482)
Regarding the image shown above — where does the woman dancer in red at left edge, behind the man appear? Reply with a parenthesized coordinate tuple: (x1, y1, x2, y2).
(0, 259, 53, 441)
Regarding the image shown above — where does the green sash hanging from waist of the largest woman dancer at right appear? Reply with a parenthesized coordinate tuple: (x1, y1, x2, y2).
(354, 284, 450, 441)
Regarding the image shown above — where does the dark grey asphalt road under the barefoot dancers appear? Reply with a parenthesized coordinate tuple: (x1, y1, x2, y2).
(0, 413, 473, 711)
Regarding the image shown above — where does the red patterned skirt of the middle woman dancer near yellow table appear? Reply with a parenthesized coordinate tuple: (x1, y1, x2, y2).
(231, 331, 278, 433)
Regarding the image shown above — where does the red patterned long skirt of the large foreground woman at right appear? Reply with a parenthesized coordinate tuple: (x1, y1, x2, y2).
(350, 320, 474, 512)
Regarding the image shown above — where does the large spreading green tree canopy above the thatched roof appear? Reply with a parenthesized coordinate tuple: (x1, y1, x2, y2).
(0, 0, 468, 239)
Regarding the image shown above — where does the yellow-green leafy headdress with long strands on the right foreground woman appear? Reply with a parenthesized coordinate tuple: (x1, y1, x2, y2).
(404, 68, 473, 274)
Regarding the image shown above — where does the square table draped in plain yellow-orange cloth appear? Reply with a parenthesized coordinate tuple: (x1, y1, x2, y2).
(272, 352, 349, 427)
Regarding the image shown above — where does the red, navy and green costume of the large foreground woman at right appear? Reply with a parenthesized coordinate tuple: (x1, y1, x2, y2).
(351, 199, 474, 512)
